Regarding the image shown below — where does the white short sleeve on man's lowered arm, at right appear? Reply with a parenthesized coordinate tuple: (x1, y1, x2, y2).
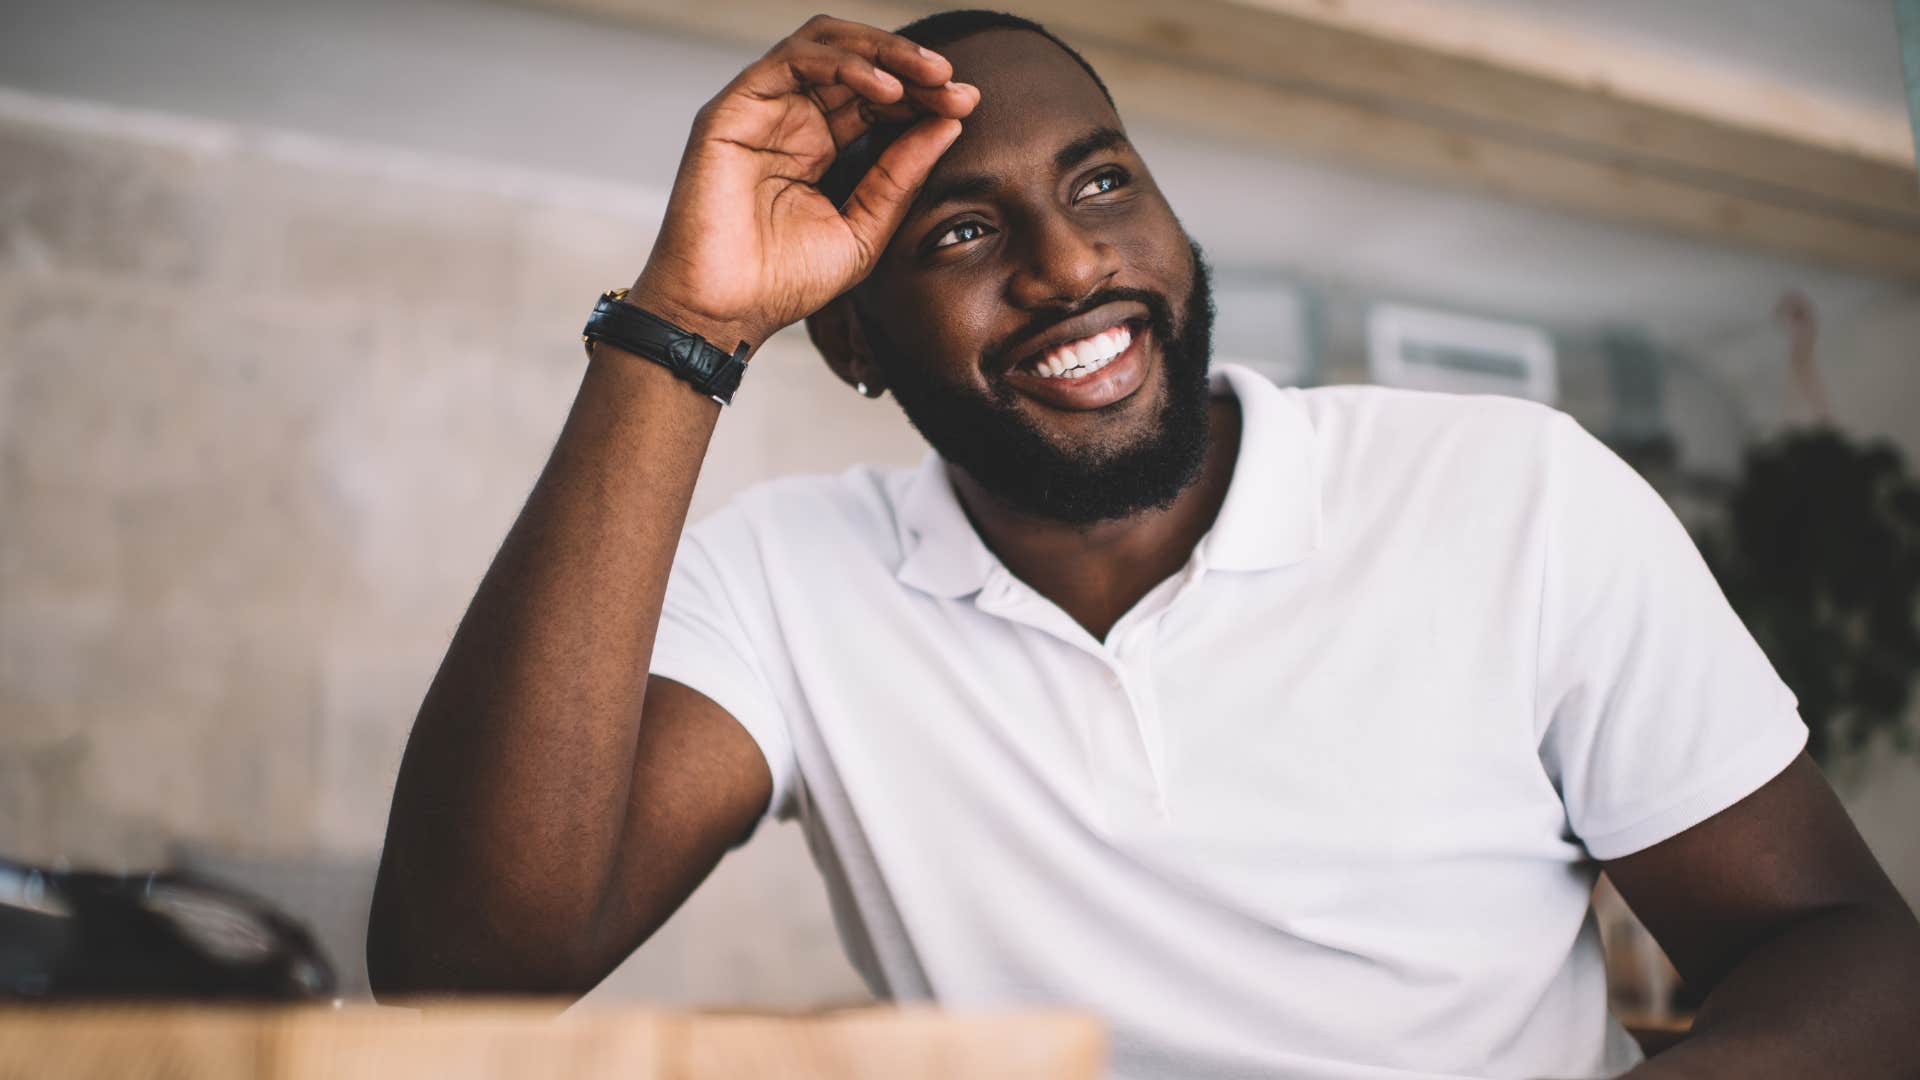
(1536, 415, 1807, 859)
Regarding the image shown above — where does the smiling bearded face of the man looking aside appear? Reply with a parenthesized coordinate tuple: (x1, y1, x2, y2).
(854, 31, 1212, 523)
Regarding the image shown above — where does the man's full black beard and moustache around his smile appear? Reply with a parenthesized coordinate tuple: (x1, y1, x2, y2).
(866, 240, 1213, 525)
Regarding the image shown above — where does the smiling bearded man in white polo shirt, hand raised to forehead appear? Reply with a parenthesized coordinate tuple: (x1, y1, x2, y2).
(369, 13, 1920, 1078)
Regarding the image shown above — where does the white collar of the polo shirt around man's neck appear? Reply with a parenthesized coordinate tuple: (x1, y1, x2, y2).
(895, 363, 1321, 598)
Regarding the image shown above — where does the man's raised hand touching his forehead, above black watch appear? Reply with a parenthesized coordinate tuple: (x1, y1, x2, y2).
(630, 15, 979, 348)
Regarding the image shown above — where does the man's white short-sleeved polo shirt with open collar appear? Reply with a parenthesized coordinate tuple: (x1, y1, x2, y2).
(653, 367, 1807, 1080)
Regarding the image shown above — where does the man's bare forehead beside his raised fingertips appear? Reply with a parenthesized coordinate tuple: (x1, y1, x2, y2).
(937, 29, 1119, 171)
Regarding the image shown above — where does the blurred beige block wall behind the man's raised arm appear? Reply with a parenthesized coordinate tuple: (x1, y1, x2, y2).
(0, 94, 890, 1005)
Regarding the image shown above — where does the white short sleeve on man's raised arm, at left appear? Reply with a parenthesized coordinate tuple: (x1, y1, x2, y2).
(649, 511, 797, 834)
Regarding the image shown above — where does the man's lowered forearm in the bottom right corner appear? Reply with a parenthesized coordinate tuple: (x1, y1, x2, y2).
(1632, 903, 1920, 1080)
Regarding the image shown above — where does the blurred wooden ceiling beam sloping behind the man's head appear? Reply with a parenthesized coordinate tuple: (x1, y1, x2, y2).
(530, 0, 1920, 281)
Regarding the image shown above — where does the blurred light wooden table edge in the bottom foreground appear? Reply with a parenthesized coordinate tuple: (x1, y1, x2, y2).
(0, 1003, 1106, 1080)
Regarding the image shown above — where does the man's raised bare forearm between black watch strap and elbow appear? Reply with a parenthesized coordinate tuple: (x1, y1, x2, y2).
(369, 346, 718, 992)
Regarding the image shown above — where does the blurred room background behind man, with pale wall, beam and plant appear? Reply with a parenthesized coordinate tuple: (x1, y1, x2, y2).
(0, 0, 1920, 1015)
